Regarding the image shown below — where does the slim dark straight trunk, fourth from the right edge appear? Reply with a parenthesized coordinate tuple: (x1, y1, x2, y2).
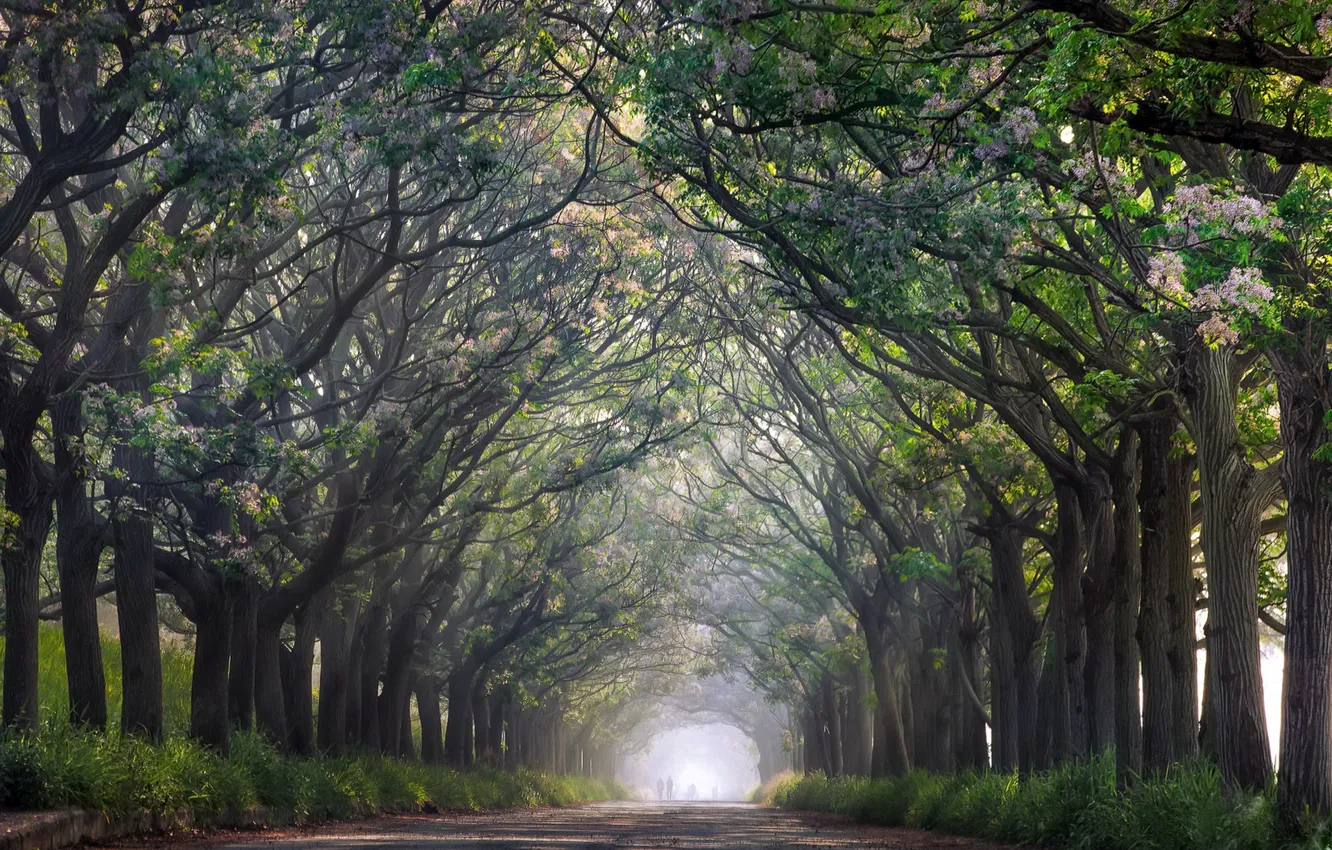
(1112, 439, 1143, 783)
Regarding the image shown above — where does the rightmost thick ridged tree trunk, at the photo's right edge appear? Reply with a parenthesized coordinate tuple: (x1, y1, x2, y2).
(1269, 343, 1332, 823)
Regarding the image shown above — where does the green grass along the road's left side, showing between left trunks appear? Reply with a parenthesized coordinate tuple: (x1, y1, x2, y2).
(0, 625, 627, 817)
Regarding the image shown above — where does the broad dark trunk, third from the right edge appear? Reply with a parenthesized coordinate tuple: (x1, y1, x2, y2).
(1138, 409, 1197, 771)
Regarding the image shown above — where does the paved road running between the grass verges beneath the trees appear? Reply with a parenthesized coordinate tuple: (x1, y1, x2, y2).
(121, 803, 995, 850)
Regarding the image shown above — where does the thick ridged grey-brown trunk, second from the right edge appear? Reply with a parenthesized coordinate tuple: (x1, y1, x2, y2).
(1184, 341, 1273, 790)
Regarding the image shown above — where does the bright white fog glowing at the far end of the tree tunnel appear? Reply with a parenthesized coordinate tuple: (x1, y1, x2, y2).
(627, 723, 759, 802)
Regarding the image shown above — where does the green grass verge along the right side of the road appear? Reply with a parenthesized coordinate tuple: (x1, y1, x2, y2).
(763, 758, 1328, 850)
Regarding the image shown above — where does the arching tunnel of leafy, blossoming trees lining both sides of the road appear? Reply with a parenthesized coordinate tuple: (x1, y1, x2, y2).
(0, 0, 1332, 842)
